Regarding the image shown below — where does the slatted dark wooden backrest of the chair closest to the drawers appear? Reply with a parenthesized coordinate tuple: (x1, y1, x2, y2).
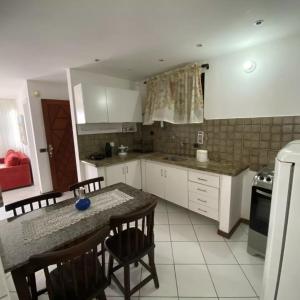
(110, 200, 157, 257)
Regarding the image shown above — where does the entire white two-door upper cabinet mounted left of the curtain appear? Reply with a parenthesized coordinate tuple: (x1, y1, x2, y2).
(74, 83, 142, 124)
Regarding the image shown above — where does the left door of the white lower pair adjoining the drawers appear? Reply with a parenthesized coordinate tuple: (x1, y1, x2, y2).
(146, 161, 165, 198)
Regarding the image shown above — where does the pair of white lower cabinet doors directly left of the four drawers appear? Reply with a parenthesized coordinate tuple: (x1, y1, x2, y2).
(145, 161, 188, 208)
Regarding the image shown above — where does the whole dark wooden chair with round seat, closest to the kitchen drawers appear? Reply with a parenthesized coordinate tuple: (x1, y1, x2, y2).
(105, 201, 159, 300)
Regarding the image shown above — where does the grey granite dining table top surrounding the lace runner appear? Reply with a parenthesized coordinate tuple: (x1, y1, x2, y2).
(0, 183, 159, 272)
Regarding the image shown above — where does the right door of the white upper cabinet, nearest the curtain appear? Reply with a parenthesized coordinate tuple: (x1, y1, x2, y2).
(106, 87, 142, 123)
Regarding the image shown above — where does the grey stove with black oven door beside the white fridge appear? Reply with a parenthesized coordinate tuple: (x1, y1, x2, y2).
(247, 167, 274, 256)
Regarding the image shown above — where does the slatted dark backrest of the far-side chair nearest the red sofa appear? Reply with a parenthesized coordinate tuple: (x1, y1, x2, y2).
(5, 192, 62, 216)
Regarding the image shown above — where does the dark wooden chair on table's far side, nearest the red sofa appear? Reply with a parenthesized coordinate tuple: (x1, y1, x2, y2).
(5, 192, 62, 300)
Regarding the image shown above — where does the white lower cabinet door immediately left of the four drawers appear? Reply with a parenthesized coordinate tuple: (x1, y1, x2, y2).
(164, 167, 188, 207)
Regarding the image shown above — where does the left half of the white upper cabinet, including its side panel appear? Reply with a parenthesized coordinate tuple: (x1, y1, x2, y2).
(74, 83, 108, 124)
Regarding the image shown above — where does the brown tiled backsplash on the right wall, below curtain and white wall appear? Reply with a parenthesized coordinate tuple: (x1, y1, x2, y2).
(142, 116, 300, 169)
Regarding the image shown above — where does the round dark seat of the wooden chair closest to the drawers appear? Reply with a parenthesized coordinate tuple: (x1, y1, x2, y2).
(105, 228, 153, 262)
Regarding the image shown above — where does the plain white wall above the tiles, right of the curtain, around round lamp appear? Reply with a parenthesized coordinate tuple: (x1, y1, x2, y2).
(204, 35, 300, 119)
